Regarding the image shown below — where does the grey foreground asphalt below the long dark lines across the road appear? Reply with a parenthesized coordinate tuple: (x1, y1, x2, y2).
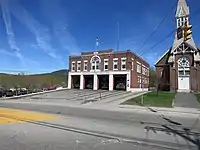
(0, 123, 181, 150)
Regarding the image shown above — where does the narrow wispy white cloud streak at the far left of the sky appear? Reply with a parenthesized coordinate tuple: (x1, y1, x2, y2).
(0, 0, 25, 66)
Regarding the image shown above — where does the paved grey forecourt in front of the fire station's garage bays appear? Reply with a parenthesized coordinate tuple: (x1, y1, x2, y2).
(1, 89, 138, 105)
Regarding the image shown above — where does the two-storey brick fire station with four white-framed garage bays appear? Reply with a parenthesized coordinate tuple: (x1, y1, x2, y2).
(68, 49, 149, 91)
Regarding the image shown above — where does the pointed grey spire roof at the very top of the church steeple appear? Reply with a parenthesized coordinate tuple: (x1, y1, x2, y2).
(176, 0, 190, 18)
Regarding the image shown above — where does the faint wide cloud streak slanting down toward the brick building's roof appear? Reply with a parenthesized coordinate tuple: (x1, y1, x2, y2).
(40, 0, 81, 55)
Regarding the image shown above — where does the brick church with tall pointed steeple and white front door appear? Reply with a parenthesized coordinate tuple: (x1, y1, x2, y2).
(155, 0, 200, 92)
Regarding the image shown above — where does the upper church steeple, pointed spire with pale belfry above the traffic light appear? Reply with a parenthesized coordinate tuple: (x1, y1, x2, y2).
(176, 0, 190, 28)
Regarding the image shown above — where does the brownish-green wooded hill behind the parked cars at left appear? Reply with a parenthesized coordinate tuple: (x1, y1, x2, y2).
(0, 70, 68, 89)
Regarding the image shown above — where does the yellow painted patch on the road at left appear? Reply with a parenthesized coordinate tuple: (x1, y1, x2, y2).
(0, 108, 58, 124)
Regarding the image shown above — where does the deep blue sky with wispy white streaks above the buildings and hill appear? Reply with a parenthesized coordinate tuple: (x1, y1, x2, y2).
(0, 0, 200, 74)
